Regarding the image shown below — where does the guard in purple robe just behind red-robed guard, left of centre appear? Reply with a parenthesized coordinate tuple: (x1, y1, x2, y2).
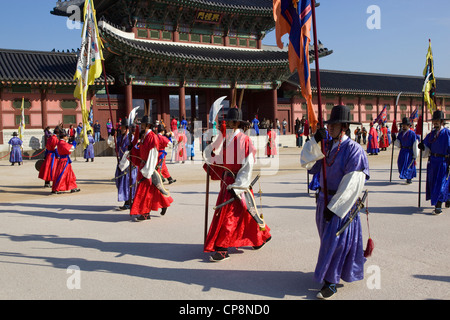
(115, 119, 137, 210)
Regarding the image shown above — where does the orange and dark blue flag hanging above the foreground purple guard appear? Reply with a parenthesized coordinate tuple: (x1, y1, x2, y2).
(273, 0, 319, 132)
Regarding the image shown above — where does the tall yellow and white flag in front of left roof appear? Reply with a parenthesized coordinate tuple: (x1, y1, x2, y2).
(74, 0, 103, 148)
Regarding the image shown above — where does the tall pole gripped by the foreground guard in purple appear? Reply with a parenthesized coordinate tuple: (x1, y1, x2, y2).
(311, 0, 328, 206)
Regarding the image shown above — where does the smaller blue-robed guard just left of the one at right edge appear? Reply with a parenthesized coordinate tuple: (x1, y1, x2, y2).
(392, 117, 419, 184)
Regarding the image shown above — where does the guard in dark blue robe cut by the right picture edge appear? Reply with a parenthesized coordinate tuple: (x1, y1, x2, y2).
(419, 110, 450, 215)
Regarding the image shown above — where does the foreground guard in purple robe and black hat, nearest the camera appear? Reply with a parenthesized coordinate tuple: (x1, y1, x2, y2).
(300, 105, 369, 299)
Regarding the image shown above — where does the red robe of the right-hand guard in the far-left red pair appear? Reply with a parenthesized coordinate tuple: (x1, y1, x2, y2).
(52, 140, 77, 192)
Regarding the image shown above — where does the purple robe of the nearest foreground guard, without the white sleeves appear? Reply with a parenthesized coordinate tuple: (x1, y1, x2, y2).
(309, 138, 370, 283)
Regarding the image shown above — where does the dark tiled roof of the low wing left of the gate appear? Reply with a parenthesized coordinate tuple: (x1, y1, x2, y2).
(0, 49, 114, 85)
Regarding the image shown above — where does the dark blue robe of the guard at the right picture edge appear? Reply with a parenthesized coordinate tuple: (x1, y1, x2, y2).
(423, 128, 450, 206)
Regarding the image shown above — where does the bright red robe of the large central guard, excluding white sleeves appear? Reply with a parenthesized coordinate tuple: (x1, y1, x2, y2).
(204, 132, 270, 252)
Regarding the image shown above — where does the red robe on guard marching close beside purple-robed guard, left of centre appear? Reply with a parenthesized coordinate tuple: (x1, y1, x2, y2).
(130, 130, 173, 215)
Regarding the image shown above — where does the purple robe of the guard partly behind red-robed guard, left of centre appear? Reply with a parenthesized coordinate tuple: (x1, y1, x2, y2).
(115, 135, 137, 201)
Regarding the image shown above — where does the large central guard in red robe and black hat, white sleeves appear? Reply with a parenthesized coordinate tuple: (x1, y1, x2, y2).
(204, 108, 271, 262)
